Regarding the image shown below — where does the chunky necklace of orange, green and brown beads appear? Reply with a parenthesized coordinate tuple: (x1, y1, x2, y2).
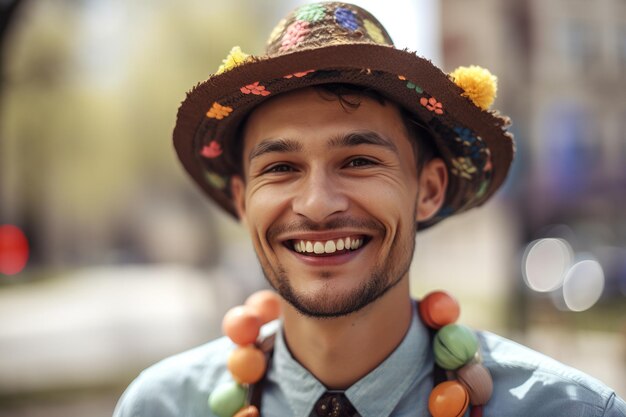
(208, 290, 493, 417)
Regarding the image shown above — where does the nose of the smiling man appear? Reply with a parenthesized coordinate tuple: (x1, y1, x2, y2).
(292, 172, 349, 222)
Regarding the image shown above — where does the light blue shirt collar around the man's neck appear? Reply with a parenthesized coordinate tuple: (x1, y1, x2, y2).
(268, 303, 430, 417)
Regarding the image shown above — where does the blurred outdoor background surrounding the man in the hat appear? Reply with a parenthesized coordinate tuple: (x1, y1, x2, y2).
(0, 0, 626, 417)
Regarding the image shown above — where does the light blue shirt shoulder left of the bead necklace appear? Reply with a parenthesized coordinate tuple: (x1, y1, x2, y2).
(113, 337, 235, 417)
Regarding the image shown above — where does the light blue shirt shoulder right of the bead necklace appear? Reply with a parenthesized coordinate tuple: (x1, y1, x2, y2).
(478, 332, 626, 417)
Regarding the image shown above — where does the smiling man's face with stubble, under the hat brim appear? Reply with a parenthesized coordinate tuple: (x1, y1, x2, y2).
(233, 88, 442, 317)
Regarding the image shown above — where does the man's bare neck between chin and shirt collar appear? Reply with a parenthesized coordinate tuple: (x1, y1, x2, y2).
(283, 277, 412, 389)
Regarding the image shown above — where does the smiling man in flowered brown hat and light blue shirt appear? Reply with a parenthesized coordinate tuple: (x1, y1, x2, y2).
(115, 3, 626, 417)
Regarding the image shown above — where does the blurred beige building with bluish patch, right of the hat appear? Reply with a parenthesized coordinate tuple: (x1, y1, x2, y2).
(442, 0, 626, 297)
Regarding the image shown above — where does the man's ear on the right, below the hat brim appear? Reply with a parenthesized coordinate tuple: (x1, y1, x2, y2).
(415, 158, 448, 222)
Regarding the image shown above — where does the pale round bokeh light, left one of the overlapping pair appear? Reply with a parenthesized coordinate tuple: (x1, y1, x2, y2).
(522, 238, 573, 292)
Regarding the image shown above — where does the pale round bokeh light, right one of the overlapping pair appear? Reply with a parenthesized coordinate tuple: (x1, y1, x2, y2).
(563, 259, 604, 311)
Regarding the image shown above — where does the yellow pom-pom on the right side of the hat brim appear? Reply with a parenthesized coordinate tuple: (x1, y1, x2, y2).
(450, 65, 498, 110)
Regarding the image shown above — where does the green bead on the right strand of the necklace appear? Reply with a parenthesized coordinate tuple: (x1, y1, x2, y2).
(433, 324, 478, 371)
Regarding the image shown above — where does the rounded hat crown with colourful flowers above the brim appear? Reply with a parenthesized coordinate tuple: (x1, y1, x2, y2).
(266, 2, 393, 56)
